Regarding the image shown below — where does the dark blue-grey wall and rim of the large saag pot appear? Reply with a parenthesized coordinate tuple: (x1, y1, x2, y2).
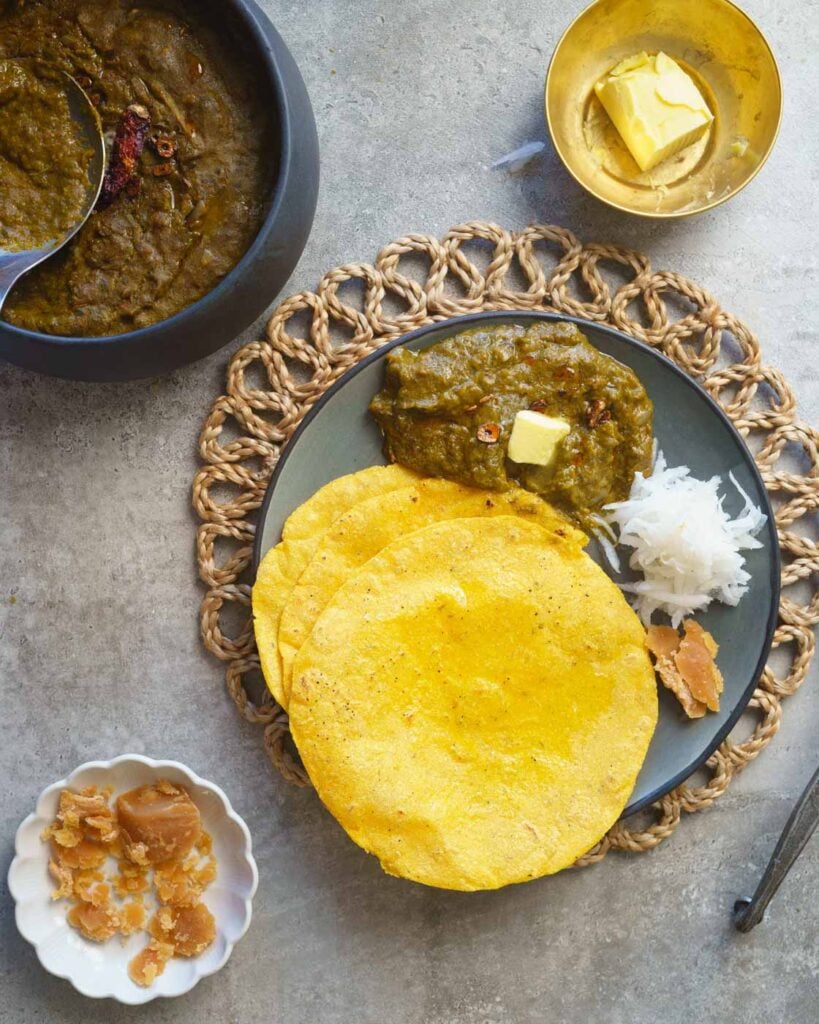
(0, 0, 318, 381)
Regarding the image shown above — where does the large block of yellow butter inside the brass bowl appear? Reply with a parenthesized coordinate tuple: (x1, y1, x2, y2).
(595, 52, 714, 171)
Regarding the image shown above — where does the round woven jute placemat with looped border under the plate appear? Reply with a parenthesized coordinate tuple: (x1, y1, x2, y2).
(192, 221, 819, 865)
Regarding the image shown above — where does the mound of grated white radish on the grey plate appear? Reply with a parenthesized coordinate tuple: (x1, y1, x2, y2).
(598, 452, 767, 627)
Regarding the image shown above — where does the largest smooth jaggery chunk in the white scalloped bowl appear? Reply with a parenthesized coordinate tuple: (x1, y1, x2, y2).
(117, 779, 202, 864)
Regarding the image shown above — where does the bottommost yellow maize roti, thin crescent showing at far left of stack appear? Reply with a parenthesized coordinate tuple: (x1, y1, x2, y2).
(253, 466, 418, 703)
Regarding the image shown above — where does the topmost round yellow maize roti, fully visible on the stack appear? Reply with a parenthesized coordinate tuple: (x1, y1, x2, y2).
(290, 516, 657, 890)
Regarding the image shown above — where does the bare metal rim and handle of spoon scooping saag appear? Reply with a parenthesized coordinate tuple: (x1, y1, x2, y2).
(0, 60, 105, 309)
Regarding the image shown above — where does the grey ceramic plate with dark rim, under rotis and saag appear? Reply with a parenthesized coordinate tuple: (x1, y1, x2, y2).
(255, 312, 780, 814)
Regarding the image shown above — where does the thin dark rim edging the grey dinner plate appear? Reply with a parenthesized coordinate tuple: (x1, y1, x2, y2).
(253, 309, 782, 818)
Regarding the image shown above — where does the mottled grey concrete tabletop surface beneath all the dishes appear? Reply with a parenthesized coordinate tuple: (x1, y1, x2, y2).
(0, 0, 819, 1024)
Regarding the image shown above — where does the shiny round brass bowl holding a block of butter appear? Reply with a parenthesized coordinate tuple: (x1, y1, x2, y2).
(546, 0, 782, 217)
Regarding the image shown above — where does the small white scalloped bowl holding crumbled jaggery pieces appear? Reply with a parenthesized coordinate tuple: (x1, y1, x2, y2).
(8, 754, 259, 1005)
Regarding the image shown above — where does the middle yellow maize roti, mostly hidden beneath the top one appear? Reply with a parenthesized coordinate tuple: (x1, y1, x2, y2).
(278, 479, 588, 708)
